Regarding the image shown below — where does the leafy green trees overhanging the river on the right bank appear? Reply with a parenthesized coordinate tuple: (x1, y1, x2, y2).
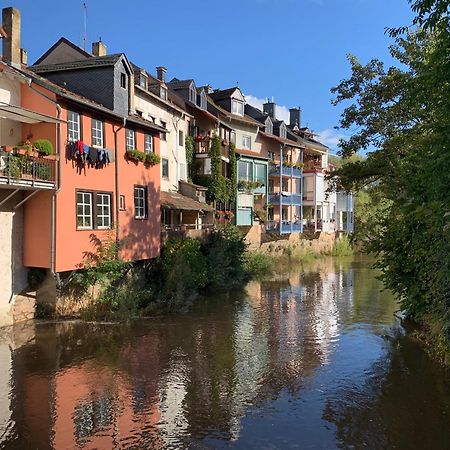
(330, 0, 450, 341)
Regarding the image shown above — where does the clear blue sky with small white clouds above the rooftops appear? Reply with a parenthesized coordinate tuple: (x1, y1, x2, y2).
(9, 0, 412, 151)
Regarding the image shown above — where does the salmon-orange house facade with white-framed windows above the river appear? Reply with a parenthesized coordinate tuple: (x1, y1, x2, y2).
(22, 79, 160, 272)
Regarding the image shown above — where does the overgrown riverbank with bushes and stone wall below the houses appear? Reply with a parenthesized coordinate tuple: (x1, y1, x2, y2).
(36, 227, 351, 320)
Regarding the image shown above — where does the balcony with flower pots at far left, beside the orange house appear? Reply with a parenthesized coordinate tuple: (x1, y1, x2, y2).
(0, 151, 56, 189)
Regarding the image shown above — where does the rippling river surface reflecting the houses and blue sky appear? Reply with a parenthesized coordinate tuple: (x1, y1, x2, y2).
(0, 259, 450, 449)
